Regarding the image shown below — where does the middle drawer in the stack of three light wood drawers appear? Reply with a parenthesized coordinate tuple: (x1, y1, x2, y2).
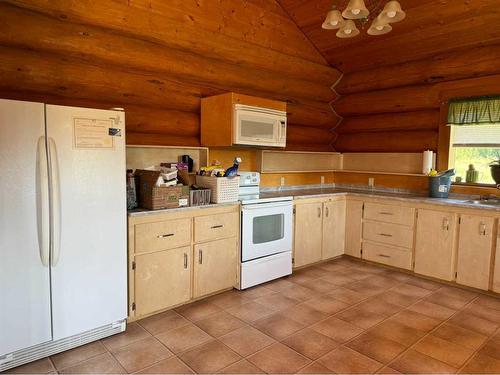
(363, 221, 413, 249)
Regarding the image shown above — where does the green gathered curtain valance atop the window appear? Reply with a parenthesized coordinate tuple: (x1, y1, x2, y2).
(448, 96, 500, 125)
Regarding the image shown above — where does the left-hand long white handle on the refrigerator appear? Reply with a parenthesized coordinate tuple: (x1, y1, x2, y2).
(36, 136, 50, 267)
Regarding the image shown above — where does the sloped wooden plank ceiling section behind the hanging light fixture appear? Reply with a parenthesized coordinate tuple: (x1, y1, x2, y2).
(278, 0, 500, 72)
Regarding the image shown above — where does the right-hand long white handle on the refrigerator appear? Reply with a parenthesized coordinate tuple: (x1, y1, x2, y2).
(49, 138, 61, 267)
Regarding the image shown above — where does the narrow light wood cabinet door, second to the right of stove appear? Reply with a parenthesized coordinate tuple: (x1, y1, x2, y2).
(321, 200, 346, 259)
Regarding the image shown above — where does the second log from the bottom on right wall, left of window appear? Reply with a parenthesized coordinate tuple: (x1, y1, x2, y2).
(335, 109, 439, 134)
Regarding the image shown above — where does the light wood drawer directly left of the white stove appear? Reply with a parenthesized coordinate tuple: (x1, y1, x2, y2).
(194, 212, 240, 242)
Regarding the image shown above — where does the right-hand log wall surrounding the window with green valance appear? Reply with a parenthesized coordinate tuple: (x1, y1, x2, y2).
(333, 45, 500, 153)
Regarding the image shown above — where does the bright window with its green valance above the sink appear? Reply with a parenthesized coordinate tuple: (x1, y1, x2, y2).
(448, 97, 500, 184)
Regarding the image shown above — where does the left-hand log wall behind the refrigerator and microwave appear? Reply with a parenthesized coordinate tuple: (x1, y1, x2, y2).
(0, 0, 341, 150)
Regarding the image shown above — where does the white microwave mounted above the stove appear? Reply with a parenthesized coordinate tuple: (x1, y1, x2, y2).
(233, 104, 286, 147)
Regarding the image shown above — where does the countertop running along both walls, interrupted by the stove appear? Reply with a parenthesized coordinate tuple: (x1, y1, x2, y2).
(128, 187, 500, 216)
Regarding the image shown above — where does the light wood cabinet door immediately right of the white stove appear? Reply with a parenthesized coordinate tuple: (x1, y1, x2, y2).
(294, 202, 323, 267)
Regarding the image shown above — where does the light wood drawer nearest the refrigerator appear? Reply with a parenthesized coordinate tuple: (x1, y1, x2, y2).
(135, 218, 191, 253)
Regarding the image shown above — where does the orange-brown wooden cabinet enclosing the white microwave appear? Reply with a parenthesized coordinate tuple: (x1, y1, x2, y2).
(201, 92, 286, 147)
